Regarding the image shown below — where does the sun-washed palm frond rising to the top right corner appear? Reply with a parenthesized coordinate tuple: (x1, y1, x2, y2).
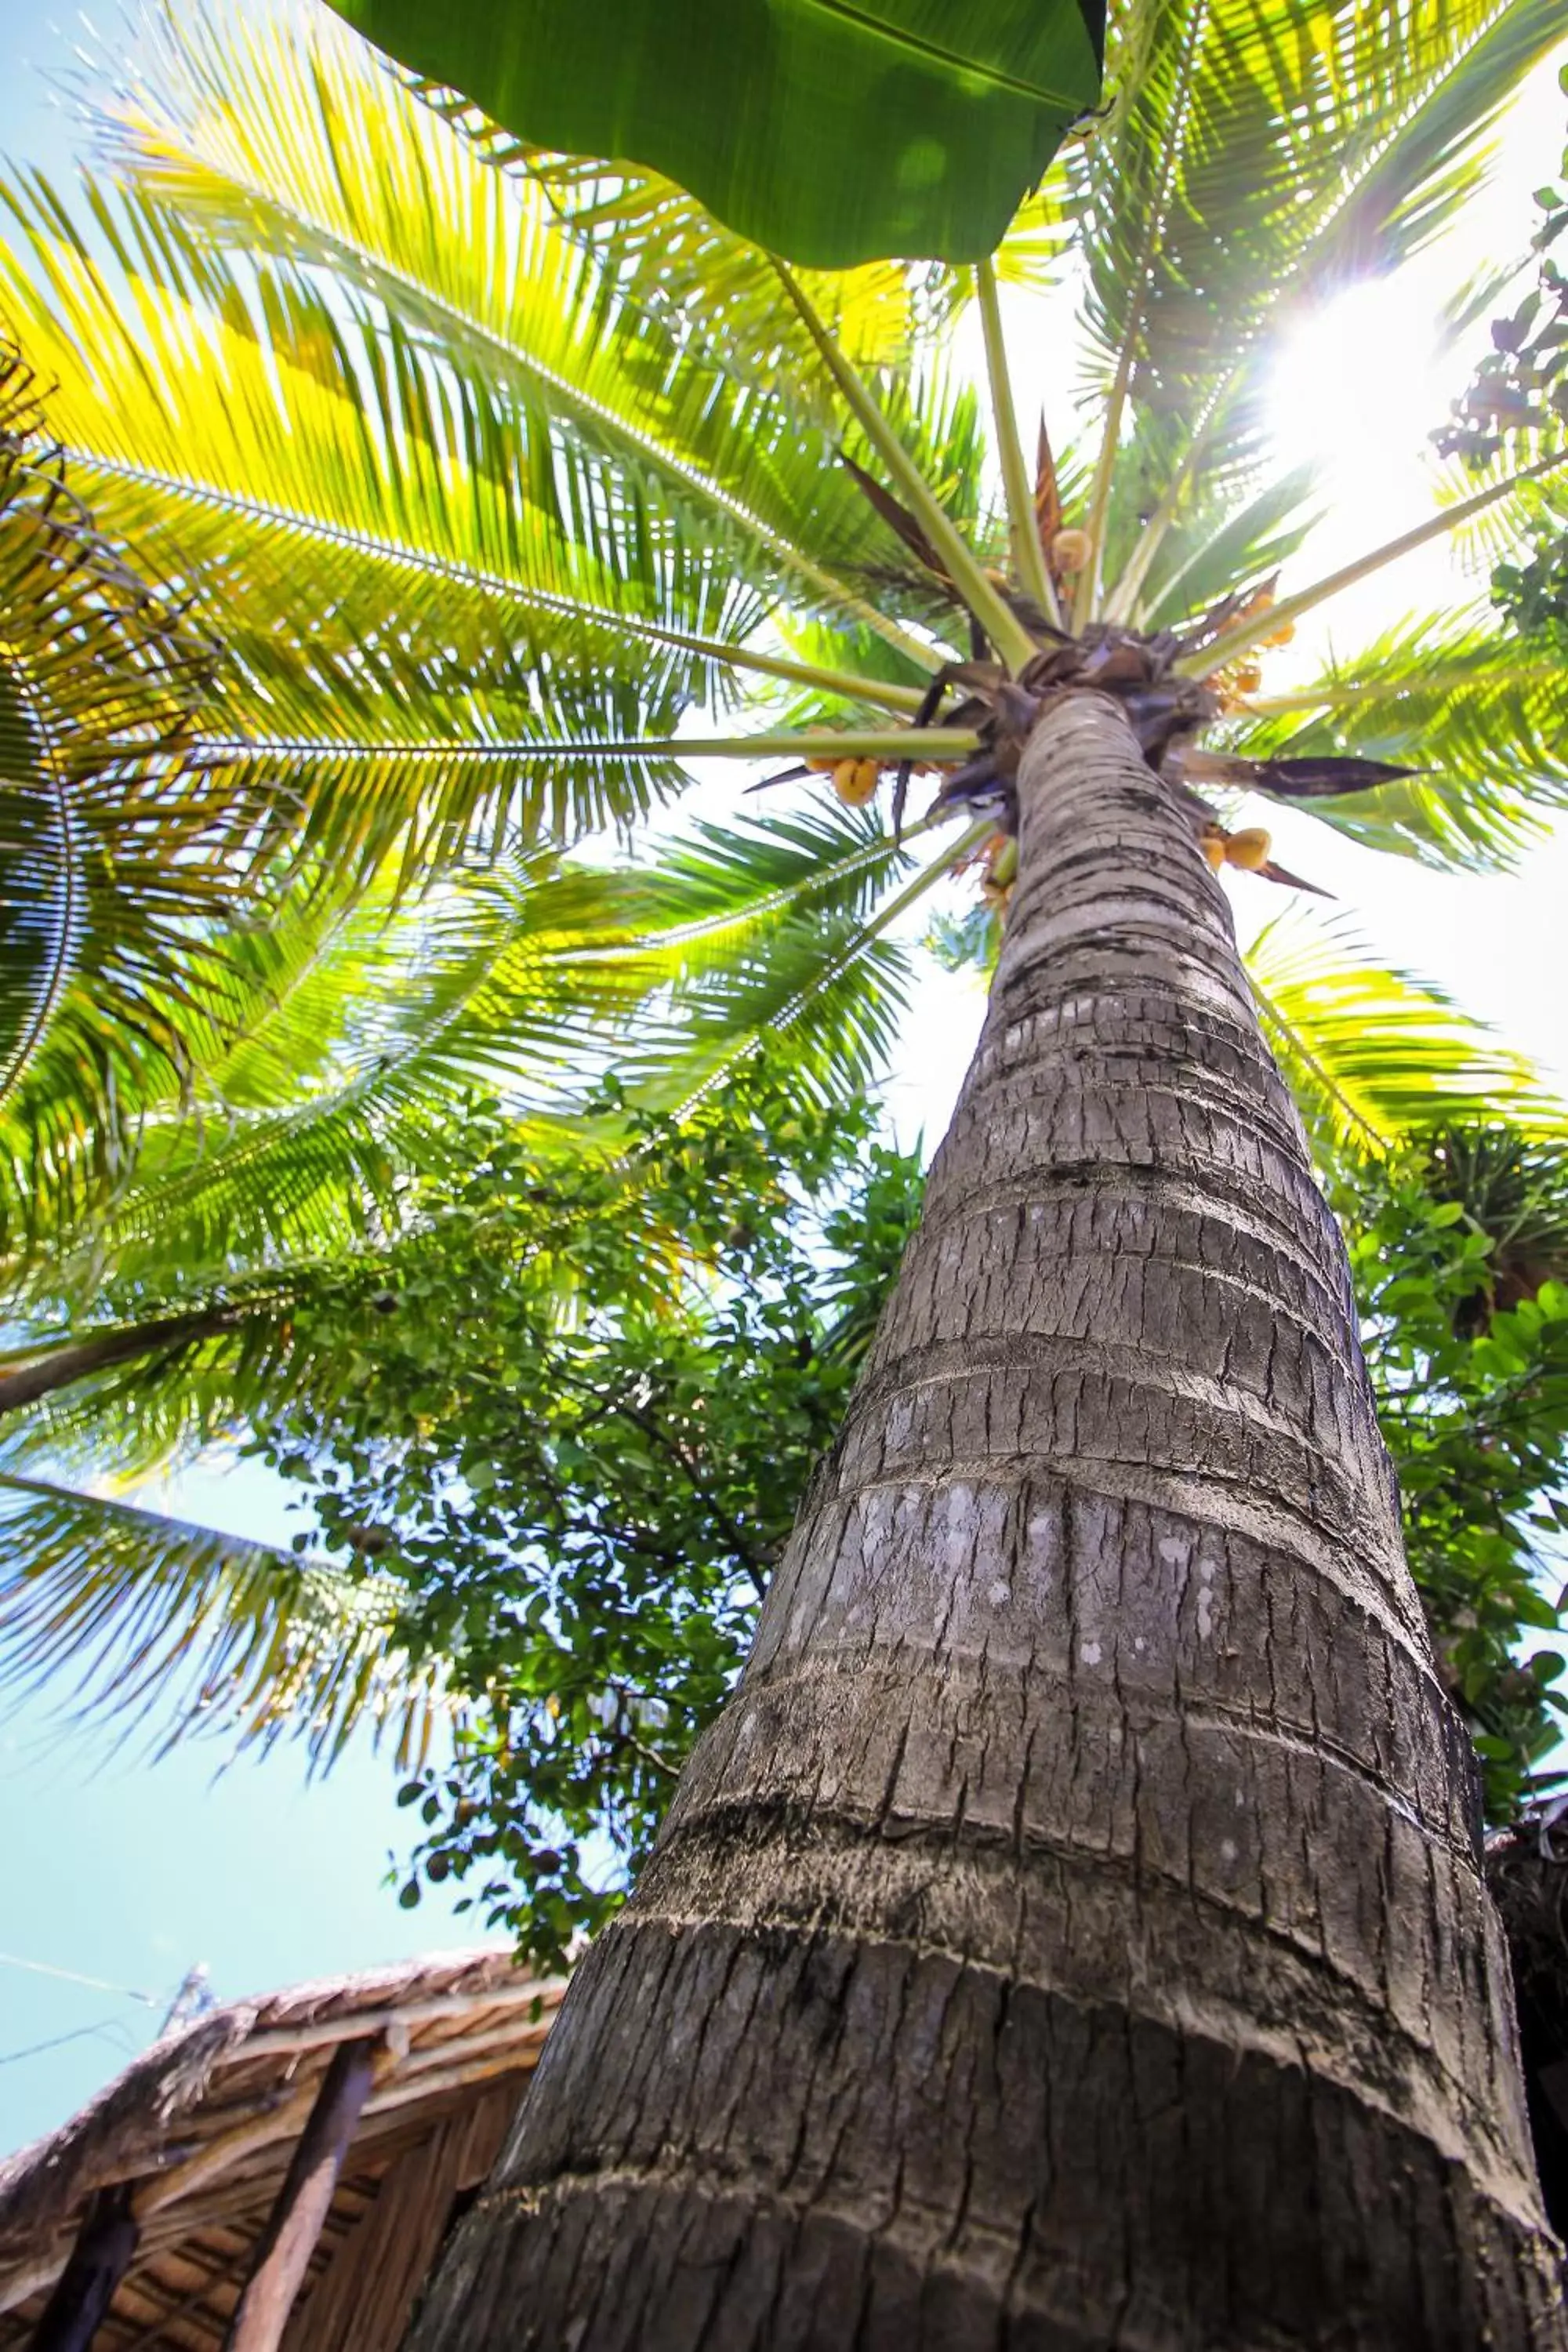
(1086, 0, 1561, 616)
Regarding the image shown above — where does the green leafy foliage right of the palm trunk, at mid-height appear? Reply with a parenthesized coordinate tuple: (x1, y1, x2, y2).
(1330, 1129, 1568, 1823)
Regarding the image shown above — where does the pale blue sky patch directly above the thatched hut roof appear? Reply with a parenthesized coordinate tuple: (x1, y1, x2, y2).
(0, 1468, 499, 2154)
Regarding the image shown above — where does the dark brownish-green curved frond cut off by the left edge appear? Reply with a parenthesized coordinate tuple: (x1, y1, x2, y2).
(0, 339, 281, 1221)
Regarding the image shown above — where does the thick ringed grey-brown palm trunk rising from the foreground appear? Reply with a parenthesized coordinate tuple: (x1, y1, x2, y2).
(416, 696, 1568, 2352)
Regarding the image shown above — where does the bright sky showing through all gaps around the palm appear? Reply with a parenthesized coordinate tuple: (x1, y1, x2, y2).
(0, 0, 1568, 2152)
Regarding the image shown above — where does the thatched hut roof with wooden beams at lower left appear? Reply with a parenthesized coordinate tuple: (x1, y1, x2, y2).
(0, 1952, 564, 2352)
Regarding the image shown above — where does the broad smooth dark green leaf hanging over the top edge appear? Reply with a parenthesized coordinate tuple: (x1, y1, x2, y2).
(321, 0, 1105, 268)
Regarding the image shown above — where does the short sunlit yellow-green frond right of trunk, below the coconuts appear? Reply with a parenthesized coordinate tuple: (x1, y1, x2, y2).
(1246, 910, 1563, 1148)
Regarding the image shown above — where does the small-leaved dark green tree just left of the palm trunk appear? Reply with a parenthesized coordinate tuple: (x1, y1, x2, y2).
(246, 1075, 916, 1966)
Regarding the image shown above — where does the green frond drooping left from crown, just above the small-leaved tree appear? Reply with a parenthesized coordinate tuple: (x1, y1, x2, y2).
(16, 802, 931, 1317)
